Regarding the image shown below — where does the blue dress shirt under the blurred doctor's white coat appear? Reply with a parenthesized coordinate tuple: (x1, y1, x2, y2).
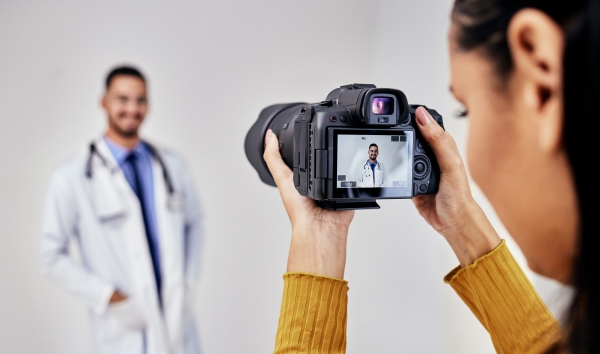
(104, 137, 161, 292)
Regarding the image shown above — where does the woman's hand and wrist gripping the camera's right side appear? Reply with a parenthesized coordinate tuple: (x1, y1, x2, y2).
(413, 107, 501, 267)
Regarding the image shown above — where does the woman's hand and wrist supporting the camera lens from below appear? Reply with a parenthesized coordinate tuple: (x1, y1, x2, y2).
(264, 129, 354, 279)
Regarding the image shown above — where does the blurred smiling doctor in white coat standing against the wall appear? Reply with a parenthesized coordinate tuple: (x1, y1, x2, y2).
(40, 67, 201, 354)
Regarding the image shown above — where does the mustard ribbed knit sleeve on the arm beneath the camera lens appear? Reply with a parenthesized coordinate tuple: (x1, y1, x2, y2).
(275, 273, 348, 354)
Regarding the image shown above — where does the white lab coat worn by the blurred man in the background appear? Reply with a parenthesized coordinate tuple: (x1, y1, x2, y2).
(40, 139, 201, 354)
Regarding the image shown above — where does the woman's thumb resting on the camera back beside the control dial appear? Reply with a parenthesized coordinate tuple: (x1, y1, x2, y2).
(415, 107, 462, 172)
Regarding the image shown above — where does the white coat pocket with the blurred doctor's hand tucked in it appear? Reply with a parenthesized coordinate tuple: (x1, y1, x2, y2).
(105, 297, 146, 337)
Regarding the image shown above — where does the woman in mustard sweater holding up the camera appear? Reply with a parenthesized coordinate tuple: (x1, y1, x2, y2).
(264, 0, 600, 353)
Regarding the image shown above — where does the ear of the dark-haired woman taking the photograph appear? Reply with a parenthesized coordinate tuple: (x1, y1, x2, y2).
(507, 9, 564, 152)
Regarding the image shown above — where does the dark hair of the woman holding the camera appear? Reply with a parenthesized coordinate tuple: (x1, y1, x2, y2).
(452, 0, 600, 353)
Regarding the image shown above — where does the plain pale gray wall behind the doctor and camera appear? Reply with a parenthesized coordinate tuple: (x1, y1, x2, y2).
(0, 0, 560, 353)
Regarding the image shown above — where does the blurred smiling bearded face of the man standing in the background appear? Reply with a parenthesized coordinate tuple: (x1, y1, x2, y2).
(102, 75, 148, 137)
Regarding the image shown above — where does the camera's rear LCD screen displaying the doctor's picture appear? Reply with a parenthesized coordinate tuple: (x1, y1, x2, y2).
(334, 130, 413, 198)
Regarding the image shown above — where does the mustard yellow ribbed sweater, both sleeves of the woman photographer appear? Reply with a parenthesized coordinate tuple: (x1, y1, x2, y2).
(275, 241, 562, 354)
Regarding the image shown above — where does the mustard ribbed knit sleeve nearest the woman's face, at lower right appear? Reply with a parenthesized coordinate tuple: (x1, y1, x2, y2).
(444, 240, 562, 353)
